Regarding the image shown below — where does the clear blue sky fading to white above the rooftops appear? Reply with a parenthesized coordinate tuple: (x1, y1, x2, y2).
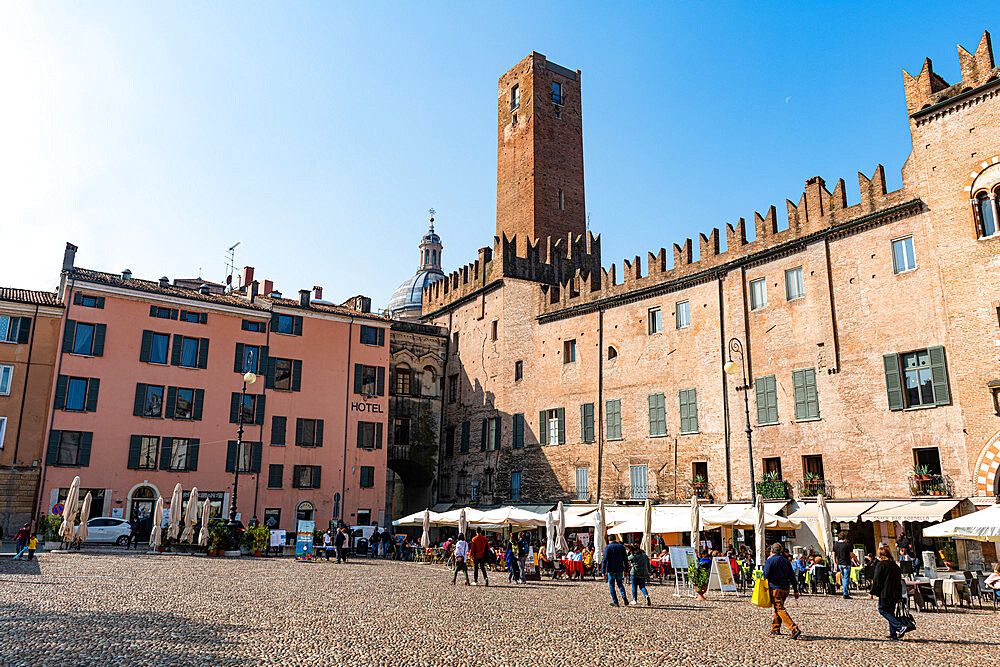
(0, 2, 1000, 306)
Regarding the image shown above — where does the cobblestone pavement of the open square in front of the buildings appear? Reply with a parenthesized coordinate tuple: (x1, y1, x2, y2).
(0, 553, 1000, 667)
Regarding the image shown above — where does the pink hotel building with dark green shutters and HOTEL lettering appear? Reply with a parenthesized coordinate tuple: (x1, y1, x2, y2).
(39, 246, 389, 531)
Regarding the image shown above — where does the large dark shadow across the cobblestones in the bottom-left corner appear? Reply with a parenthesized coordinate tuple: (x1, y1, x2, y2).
(0, 603, 257, 665)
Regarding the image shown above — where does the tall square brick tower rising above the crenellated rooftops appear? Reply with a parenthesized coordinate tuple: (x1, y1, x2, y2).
(497, 53, 587, 251)
